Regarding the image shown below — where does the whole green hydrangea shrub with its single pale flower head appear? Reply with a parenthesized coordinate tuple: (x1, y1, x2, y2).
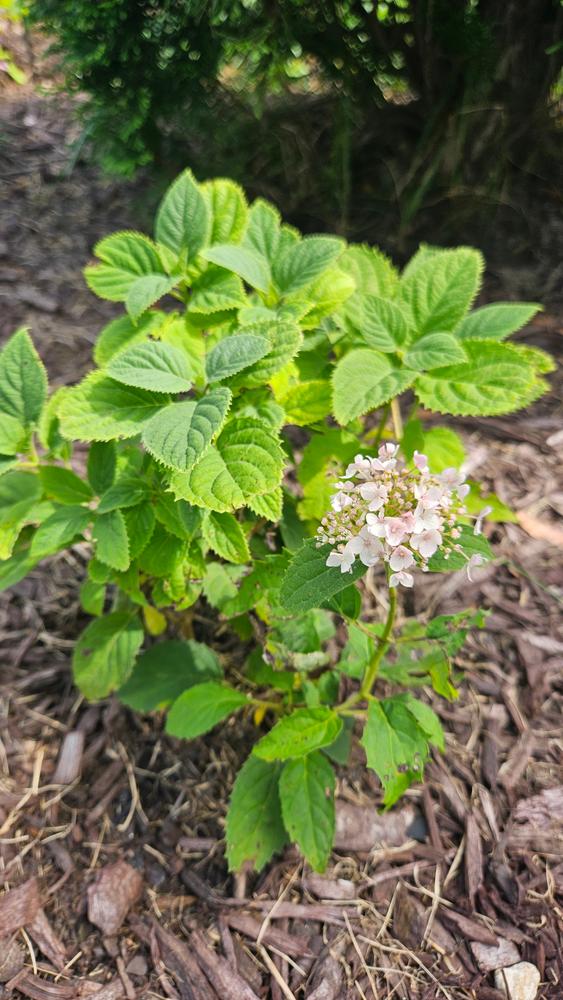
(0, 171, 552, 870)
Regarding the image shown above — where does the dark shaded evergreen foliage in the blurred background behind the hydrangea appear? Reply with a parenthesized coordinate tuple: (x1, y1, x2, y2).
(11, 0, 563, 254)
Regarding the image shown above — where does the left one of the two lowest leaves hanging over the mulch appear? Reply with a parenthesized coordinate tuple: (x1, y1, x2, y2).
(226, 756, 287, 871)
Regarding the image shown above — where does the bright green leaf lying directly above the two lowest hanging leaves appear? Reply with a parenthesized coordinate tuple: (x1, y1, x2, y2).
(253, 708, 342, 760)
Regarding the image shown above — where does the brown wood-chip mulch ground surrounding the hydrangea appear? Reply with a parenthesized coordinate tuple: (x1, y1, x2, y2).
(0, 60, 563, 1000)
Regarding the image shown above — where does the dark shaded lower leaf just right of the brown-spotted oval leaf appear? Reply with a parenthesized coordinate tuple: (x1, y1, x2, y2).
(117, 639, 222, 712)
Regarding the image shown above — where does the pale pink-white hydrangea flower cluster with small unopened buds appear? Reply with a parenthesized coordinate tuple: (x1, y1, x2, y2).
(317, 444, 488, 587)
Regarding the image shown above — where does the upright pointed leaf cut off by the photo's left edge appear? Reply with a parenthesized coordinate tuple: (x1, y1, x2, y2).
(0, 330, 47, 427)
